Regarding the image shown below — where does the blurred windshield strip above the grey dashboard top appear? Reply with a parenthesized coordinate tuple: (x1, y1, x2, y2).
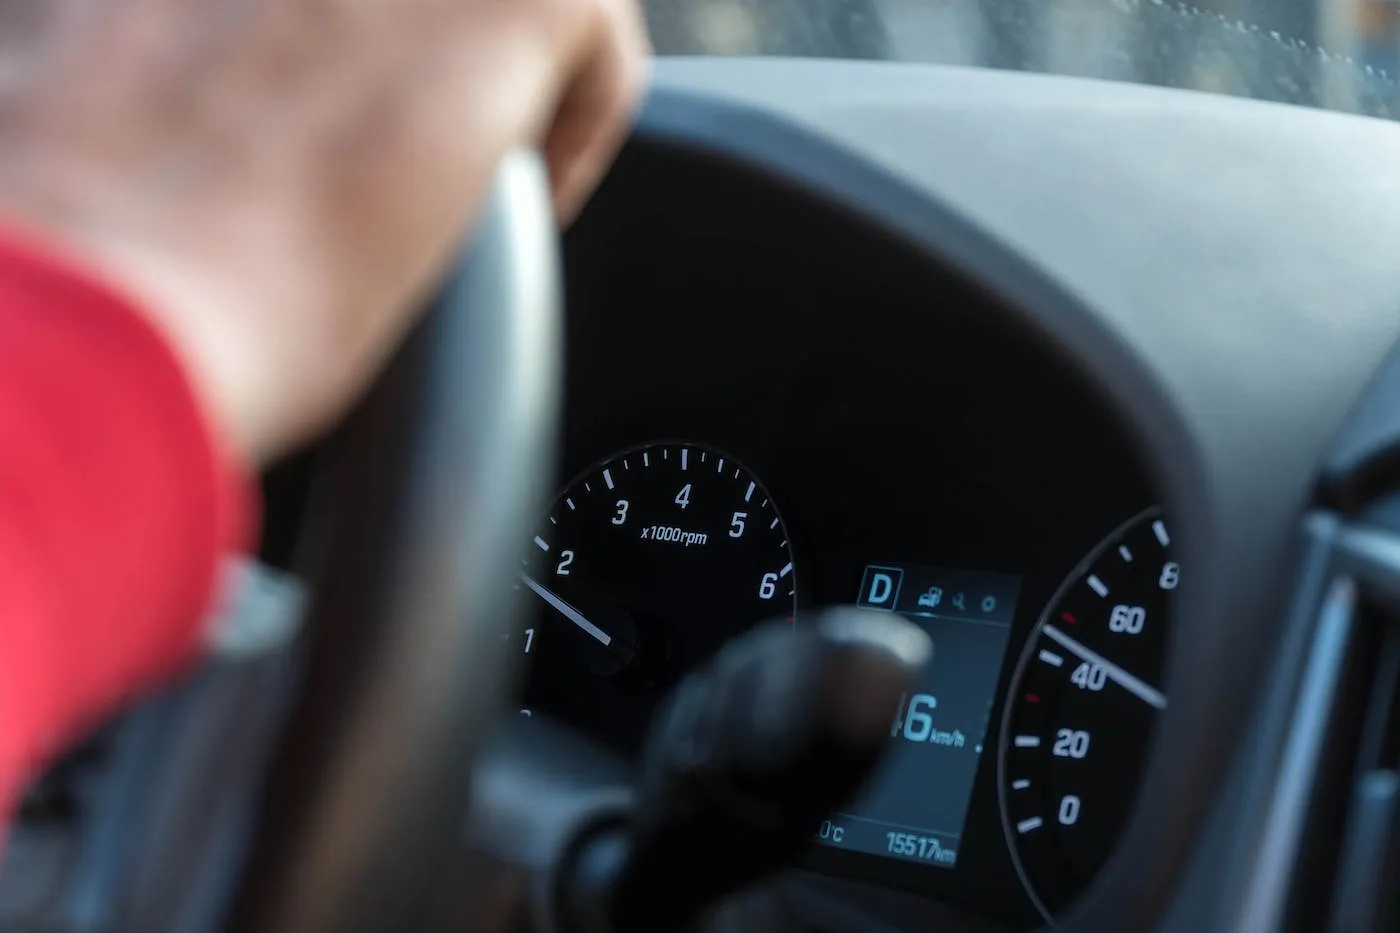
(645, 0, 1400, 118)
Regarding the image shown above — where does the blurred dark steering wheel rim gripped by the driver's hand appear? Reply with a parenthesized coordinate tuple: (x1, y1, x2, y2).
(234, 153, 561, 933)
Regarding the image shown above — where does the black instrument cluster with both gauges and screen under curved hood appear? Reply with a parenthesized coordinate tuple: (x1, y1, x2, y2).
(521, 128, 1180, 929)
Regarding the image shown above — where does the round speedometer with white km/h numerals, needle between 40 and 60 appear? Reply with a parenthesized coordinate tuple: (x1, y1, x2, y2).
(1000, 510, 1182, 919)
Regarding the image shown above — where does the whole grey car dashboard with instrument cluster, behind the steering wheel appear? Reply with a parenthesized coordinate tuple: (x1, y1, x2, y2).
(13, 59, 1400, 933)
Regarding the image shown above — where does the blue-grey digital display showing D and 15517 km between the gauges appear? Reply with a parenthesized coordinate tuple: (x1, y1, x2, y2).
(818, 565, 1021, 869)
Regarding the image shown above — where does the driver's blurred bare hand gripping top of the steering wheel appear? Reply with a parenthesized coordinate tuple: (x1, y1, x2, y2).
(0, 0, 645, 465)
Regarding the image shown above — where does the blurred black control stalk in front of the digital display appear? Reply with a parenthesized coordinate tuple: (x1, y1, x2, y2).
(570, 609, 932, 933)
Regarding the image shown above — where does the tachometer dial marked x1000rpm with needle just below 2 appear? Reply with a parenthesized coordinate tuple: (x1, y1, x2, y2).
(521, 443, 797, 754)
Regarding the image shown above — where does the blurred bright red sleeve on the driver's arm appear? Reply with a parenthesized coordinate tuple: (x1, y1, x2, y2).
(0, 237, 252, 812)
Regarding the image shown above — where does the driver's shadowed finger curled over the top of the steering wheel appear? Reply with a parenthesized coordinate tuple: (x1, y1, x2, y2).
(545, 0, 650, 224)
